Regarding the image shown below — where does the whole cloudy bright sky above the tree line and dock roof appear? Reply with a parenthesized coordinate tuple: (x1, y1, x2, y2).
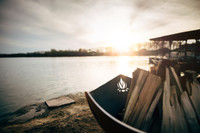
(0, 0, 200, 53)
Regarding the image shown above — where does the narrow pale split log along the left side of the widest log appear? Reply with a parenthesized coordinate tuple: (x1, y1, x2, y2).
(123, 69, 149, 123)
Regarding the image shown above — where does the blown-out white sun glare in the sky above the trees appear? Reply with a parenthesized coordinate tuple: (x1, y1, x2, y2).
(86, 17, 143, 53)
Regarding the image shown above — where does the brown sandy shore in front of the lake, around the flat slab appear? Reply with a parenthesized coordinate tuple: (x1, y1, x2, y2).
(0, 93, 104, 133)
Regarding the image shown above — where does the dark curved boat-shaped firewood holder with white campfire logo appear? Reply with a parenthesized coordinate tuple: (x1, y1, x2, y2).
(85, 75, 143, 133)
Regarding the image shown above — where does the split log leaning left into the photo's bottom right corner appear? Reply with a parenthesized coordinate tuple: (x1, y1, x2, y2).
(180, 91, 200, 133)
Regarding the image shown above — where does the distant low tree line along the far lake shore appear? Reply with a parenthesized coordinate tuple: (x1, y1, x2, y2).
(0, 48, 168, 57)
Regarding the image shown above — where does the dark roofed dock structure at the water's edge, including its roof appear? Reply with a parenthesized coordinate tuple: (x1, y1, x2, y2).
(149, 29, 200, 72)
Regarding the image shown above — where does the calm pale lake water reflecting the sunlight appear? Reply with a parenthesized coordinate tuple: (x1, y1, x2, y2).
(0, 56, 149, 115)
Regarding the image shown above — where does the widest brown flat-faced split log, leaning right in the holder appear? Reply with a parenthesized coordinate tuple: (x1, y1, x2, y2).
(128, 74, 161, 128)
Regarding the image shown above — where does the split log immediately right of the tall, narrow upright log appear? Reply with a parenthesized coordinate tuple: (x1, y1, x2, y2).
(170, 86, 189, 133)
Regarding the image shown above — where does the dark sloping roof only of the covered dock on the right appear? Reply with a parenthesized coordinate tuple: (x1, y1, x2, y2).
(150, 29, 200, 41)
